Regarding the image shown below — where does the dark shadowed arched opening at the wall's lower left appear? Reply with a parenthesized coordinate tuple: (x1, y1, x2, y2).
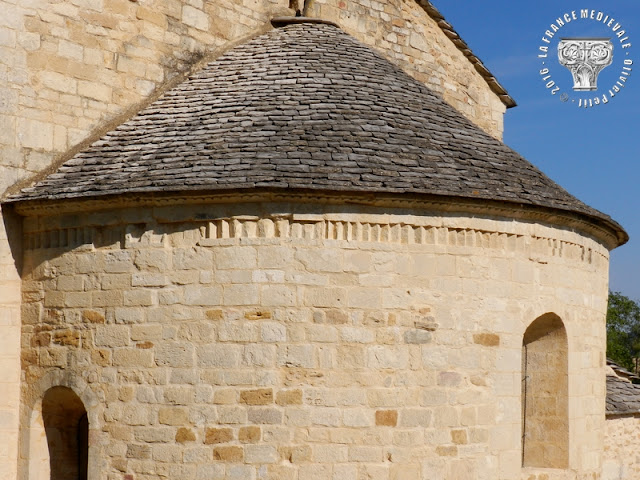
(42, 387, 89, 480)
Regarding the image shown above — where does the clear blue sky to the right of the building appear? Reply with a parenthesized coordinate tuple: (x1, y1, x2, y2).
(433, 0, 640, 300)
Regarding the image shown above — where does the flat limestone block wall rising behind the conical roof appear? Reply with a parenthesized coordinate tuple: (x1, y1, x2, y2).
(0, 0, 504, 480)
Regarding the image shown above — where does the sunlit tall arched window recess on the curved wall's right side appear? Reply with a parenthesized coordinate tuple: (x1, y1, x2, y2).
(522, 313, 569, 468)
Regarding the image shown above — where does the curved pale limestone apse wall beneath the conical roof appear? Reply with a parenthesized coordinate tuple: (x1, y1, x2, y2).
(21, 198, 608, 480)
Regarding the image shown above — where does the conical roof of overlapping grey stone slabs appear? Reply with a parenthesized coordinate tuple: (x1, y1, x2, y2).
(12, 18, 626, 243)
